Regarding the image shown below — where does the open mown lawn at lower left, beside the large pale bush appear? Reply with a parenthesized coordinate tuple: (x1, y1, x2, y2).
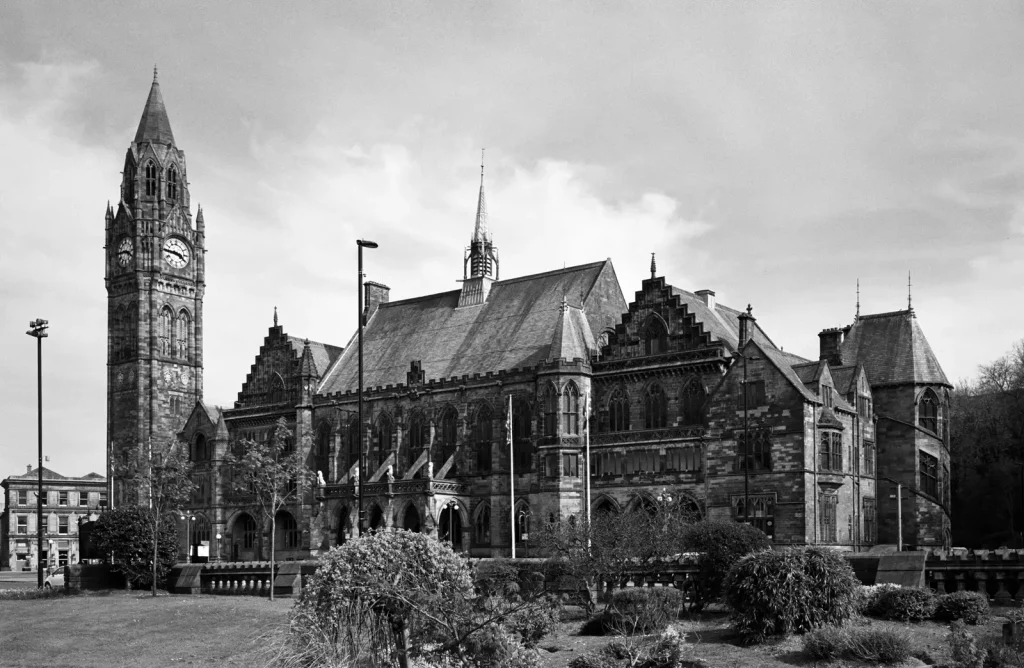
(0, 591, 293, 668)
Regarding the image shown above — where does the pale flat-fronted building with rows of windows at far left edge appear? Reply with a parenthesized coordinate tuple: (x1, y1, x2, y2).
(0, 466, 106, 571)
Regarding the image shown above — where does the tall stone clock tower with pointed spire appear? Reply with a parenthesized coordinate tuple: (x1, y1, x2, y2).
(104, 69, 206, 504)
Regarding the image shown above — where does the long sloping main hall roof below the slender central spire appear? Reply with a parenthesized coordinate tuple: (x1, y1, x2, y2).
(318, 260, 626, 394)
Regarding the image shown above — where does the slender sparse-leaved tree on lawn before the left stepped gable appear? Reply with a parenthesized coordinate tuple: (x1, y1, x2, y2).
(227, 418, 313, 600)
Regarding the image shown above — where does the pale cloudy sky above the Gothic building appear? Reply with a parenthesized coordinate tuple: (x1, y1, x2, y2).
(0, 0, 1024, 478)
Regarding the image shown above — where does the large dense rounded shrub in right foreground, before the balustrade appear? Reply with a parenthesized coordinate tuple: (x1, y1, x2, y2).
(723, 548, 859, 641)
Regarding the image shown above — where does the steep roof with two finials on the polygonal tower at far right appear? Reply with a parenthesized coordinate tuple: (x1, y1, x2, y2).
(841, 310, 949, 386)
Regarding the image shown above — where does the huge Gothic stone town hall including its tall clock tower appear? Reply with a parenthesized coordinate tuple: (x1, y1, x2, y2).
(106, 74, 949, 559)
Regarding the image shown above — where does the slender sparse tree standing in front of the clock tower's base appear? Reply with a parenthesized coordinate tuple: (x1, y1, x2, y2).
(112, 440, 196, 596)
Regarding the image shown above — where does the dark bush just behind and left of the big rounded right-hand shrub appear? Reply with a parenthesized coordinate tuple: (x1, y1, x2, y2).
(682, 519, 771, 610)
